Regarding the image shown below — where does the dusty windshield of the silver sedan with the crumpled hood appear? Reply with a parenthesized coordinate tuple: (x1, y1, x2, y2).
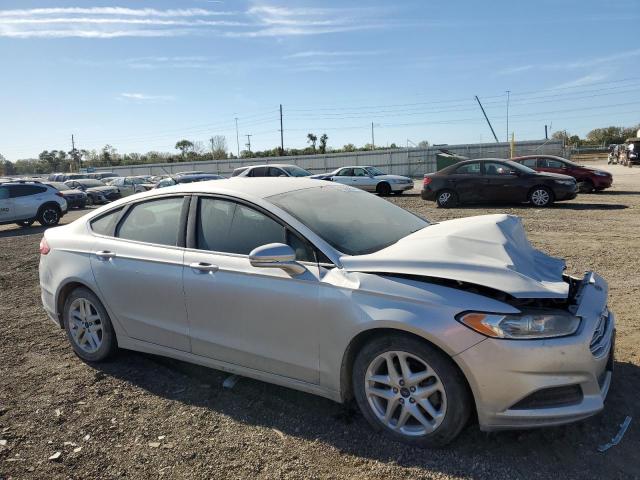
(269, 185, 429, 255)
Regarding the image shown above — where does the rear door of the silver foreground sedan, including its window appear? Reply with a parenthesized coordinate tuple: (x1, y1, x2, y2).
(91, 195, 190, 352)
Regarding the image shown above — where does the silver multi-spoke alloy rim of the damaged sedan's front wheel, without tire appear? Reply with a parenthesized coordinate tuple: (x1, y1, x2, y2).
(365, 351, 447, 436)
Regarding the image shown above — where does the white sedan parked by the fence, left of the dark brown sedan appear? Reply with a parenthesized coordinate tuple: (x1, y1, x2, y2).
(311, 166, 413, 195)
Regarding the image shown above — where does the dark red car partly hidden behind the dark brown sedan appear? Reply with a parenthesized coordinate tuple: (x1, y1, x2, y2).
(512, 155, 613, 193)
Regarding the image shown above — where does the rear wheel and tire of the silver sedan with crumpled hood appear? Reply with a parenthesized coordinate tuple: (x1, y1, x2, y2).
(63, 287, 118, 362)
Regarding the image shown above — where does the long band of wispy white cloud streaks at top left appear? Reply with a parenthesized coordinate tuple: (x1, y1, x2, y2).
(0, 2, 389, 38)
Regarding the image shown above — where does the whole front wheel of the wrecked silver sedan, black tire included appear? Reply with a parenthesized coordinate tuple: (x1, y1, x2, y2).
(353, 335, 471, 448)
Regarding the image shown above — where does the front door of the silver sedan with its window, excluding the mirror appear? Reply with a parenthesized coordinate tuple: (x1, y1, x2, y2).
(184, 197, 321, 384)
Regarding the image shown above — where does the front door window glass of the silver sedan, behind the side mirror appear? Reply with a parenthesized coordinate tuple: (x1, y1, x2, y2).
(197, 198, 285, 255)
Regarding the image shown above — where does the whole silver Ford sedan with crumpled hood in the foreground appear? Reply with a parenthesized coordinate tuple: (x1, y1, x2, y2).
(40, 178, 615, 446)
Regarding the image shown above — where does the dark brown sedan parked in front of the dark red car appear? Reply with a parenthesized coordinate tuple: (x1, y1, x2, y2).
(422, 159, 578, 208)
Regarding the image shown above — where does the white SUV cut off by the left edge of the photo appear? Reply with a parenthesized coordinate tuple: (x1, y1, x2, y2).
(0, 180, 68, 227)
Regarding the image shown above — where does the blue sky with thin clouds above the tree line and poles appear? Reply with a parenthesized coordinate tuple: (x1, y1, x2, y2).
(0, 0, 640, 160)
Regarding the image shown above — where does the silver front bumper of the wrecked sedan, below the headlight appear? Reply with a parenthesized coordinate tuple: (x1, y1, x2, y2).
(455, 272, 615, 430)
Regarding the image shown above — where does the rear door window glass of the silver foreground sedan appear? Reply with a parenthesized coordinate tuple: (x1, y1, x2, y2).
(116, 197, 184, 246)
